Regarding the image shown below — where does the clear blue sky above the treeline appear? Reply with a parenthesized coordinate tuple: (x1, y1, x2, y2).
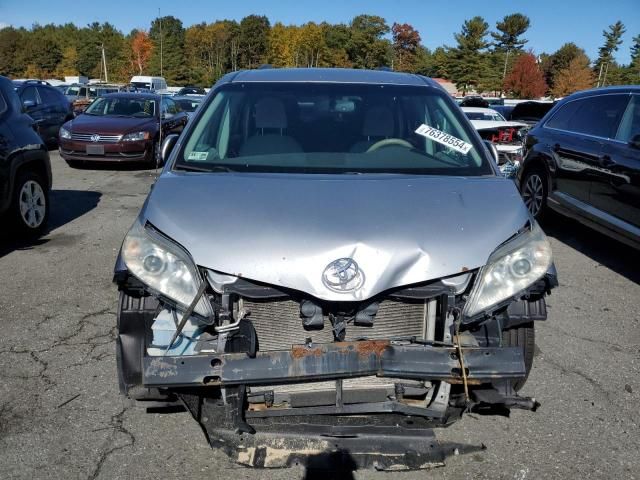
(0, 0, 640, 63)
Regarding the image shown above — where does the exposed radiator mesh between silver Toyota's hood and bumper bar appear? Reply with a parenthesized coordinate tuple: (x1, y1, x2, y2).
(243, 299, 427, 351)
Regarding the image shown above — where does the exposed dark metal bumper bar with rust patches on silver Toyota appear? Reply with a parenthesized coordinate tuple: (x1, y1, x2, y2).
(143, 341, 525, 387)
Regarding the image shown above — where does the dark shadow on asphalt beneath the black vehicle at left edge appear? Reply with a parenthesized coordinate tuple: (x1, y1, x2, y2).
(0, 190, 102, 258)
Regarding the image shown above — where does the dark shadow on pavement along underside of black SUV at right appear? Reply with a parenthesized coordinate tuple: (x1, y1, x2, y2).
(542, 212, 640, 284)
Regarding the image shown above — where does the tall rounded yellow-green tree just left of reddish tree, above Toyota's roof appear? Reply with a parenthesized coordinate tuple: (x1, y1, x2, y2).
(347, 15, 391, 68)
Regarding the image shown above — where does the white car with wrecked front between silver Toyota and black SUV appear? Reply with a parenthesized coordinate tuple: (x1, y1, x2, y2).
(462, 107, 528, 178)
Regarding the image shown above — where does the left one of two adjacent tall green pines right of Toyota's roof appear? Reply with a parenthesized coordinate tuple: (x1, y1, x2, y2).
(447, 17, 489, 94)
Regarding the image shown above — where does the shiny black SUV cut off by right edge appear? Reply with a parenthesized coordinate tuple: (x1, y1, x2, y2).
(519, 86, 640, 248)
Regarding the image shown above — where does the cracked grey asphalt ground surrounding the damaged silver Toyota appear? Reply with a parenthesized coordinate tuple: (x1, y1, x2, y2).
(0, 152, 640, 480)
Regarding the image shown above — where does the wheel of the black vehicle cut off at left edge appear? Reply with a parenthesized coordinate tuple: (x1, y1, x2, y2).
(11, 172, 49, 237)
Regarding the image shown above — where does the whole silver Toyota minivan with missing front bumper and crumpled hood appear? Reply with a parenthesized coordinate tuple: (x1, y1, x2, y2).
(114, 69, 556, 470)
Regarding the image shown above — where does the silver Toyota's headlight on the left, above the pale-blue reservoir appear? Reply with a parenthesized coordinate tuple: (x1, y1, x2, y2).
(122, 221, 213, 317)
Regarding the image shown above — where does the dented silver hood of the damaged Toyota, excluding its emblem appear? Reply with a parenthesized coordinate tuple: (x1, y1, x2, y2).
(140, 172, 529, 301)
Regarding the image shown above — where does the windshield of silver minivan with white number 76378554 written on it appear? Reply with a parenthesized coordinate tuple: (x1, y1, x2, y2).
(174, 82, 493, 175)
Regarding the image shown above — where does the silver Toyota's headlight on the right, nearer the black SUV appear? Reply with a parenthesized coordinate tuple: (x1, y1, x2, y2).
(463, 223, 553, 318)
